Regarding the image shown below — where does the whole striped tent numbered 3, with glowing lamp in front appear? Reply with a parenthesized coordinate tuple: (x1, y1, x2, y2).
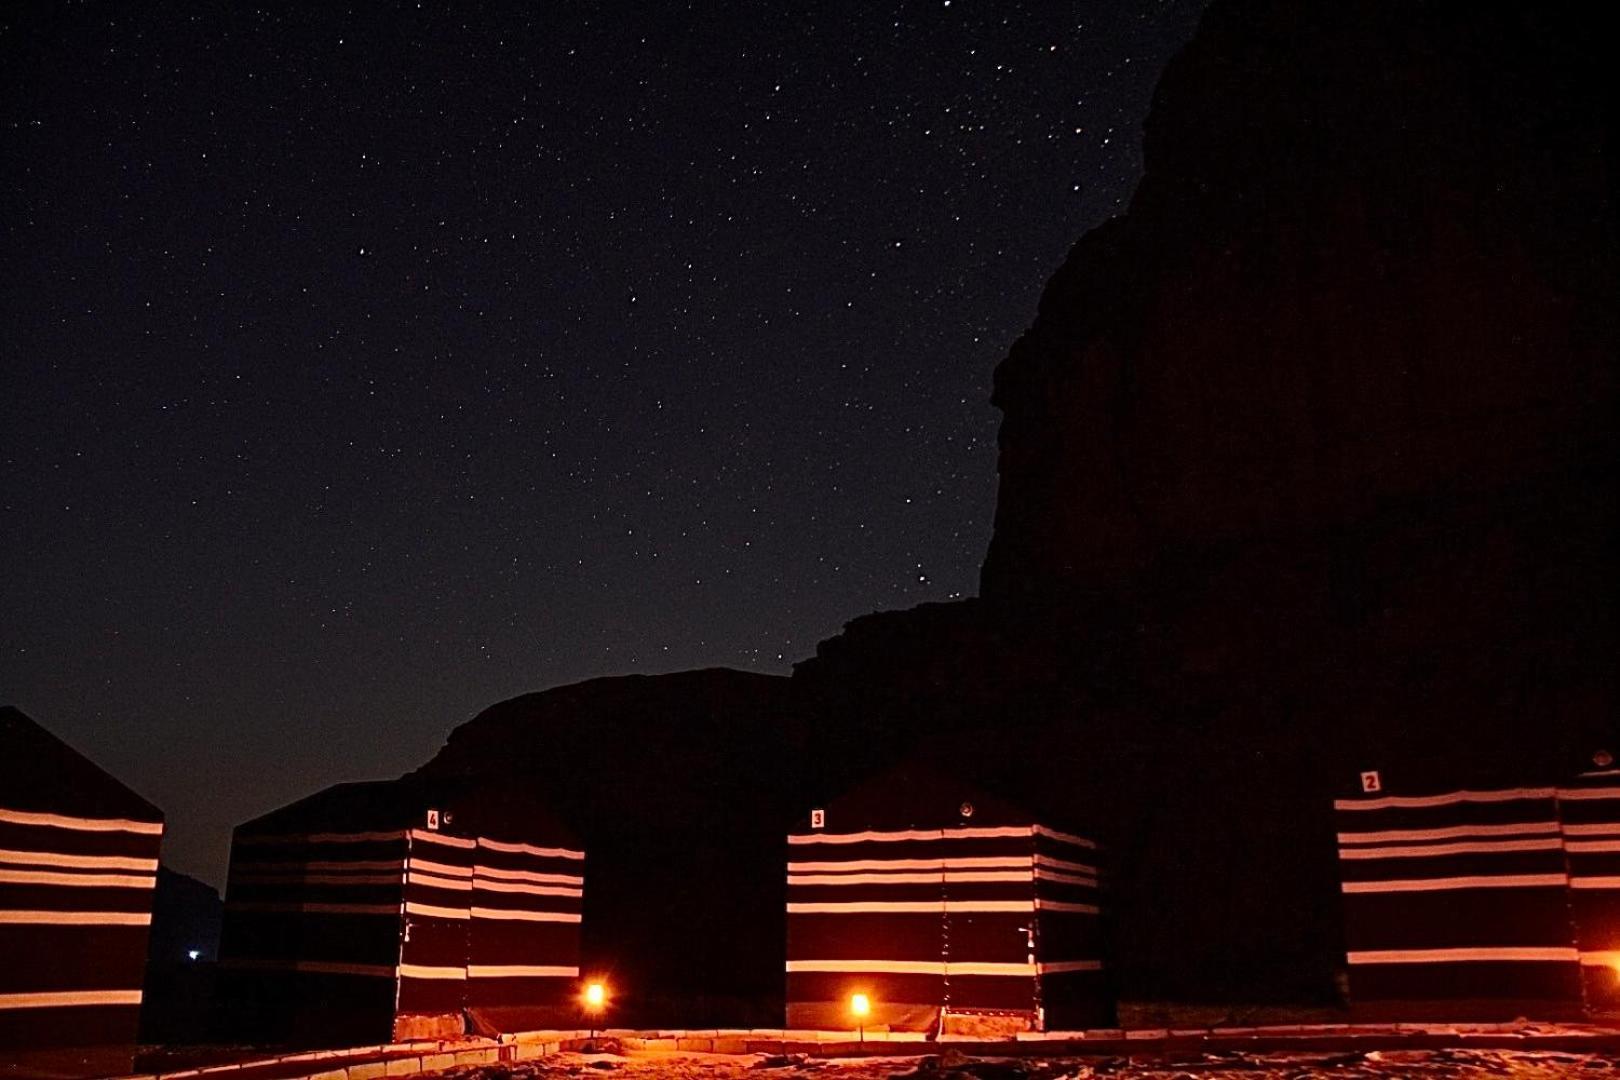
(787, 766, 1111, 1033)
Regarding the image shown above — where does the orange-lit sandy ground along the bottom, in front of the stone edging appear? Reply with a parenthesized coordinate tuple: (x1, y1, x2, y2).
(446, 1049, 1620, 1080)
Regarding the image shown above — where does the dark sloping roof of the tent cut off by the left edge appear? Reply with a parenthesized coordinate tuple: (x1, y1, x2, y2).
(0, 706, 164, 821)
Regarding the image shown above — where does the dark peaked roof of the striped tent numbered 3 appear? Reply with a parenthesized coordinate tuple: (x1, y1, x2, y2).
(826, 761, 1037, 832)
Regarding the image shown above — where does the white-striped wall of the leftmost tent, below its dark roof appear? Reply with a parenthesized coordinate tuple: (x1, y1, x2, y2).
(0, 803, 164, 1051)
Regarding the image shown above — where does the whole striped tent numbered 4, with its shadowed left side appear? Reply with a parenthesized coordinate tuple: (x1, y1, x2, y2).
(220, 777, 585, 1043)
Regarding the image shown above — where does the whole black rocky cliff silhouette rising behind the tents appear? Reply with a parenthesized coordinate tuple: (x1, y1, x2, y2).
(426, 0, 1620, 1023)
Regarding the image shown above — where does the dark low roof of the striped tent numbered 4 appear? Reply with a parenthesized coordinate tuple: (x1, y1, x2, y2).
(238, 774, 573, 845)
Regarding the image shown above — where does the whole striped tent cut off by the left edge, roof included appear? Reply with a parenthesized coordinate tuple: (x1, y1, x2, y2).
(0, 708, 164, 1051)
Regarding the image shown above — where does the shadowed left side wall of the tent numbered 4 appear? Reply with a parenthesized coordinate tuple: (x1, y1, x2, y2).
(220, 827, 407, 1041)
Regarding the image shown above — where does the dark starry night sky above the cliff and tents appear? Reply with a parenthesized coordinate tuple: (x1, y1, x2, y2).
(0, 0, 1202, 882)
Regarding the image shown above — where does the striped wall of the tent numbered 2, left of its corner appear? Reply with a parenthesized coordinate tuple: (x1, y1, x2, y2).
(1333, 772, 1581, 1020)
